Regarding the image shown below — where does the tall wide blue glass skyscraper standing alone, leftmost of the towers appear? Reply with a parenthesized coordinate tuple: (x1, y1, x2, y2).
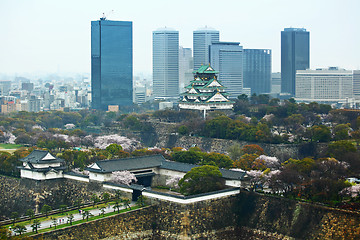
(91, 17, 133, 110)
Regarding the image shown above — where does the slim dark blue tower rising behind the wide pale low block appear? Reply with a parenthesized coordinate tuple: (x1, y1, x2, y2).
(281, 28, 310, 96)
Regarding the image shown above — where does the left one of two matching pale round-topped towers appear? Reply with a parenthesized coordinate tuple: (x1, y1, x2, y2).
(153, 28, 179, 99)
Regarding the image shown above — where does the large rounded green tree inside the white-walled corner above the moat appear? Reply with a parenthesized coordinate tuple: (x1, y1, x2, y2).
(179, 165, 225, 195)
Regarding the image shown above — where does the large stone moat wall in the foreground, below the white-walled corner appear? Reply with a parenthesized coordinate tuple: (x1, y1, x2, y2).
(31, 192, 360, 240)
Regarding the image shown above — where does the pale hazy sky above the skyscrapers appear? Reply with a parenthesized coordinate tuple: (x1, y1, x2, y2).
(0, 0, 360, 74)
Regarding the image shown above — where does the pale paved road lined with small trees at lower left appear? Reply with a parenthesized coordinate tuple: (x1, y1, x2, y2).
(13, 202, 135, 235)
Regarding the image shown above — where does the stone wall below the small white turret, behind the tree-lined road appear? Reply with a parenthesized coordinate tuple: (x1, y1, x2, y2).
(0, 175, 108, 219)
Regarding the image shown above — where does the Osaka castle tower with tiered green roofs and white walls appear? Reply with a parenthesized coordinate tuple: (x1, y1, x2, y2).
(179, 65, 234, 113)
